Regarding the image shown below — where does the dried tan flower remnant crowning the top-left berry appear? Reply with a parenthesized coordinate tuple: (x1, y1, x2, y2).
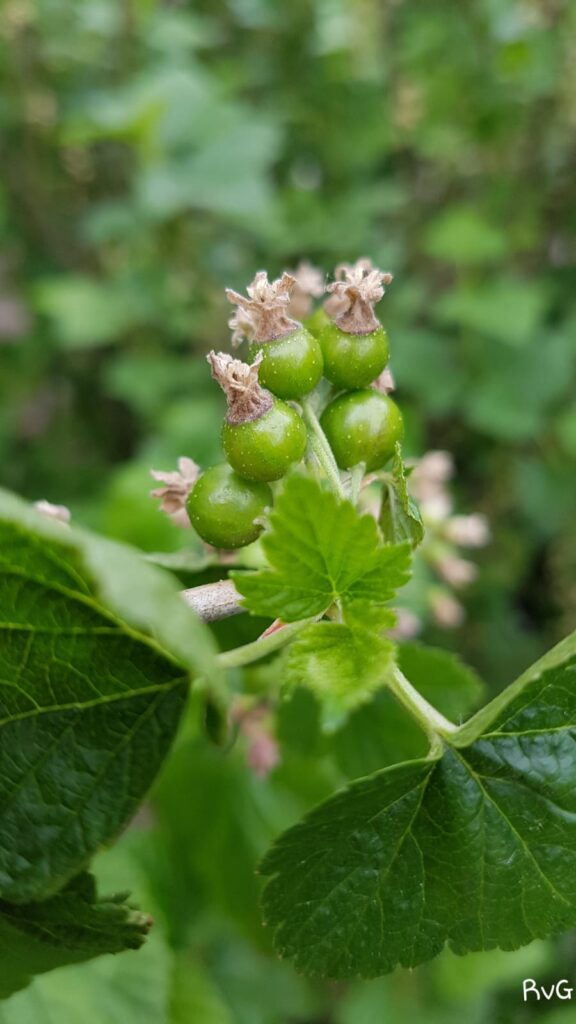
(227, 270, 299, 344)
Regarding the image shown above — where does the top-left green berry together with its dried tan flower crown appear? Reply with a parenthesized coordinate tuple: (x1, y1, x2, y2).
(227, 271, 323, 398)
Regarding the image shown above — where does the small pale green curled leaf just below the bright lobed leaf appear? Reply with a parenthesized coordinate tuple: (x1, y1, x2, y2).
(285, 612, 394, 727)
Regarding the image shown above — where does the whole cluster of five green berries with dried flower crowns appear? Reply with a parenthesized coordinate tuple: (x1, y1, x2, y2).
(178, 260, 403, 549)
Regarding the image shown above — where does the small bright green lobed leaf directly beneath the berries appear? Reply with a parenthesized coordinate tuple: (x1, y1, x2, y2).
(232, 476, 410, 623)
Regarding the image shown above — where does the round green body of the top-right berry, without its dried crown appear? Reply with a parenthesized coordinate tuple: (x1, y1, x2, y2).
(320, 324, 389, 389)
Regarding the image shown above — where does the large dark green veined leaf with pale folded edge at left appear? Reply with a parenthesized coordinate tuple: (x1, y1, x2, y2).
(0, 493, 214, 903)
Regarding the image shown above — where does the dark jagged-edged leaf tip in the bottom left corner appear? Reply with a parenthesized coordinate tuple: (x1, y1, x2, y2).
(0, 873, 152, 999)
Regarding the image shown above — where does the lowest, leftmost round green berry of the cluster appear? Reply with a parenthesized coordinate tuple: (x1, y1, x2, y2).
(187, 463, 273, 548)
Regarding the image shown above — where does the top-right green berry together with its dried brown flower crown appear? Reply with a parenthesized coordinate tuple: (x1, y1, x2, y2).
(320, 260, 392, 389)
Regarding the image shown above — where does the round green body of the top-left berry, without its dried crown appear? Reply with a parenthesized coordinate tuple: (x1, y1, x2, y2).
(250, 327, 322, 398)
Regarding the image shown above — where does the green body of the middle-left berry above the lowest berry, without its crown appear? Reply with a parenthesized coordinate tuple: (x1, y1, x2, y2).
(222, 398, 306, 480)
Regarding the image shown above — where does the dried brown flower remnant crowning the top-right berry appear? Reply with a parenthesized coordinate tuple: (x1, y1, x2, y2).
(325, 259, 393, 334)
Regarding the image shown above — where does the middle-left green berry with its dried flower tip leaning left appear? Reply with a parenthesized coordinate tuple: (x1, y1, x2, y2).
(208, 352, 307, 480)
